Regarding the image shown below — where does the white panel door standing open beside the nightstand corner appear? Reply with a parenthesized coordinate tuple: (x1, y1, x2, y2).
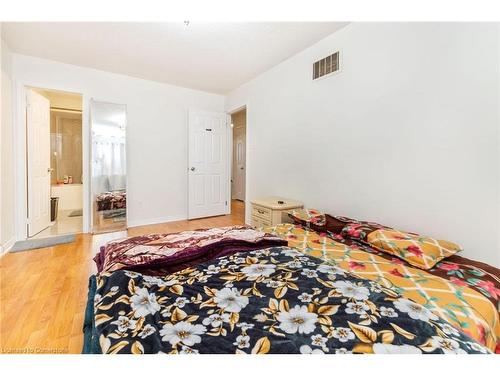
(188, 110, 229, 219)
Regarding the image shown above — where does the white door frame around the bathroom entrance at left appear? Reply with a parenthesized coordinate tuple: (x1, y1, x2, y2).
(13, 79, 90, 241)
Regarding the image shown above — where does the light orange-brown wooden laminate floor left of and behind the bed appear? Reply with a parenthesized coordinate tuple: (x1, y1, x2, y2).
(0, 201, 244, 353)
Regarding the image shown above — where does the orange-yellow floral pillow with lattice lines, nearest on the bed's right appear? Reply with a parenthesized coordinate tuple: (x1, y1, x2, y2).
(364, 228, 462, 270)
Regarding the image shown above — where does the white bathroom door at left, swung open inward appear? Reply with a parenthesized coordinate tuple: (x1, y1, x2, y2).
(26, 89, 51, 237)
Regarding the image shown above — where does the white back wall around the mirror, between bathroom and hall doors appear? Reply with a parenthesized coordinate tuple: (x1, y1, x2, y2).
(13, 54, 224, 235)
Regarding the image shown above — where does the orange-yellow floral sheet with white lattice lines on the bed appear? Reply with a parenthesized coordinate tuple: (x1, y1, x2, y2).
(263, 224, 500, 351)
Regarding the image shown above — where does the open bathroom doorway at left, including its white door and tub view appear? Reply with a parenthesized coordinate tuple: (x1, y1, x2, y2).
(26, 88, 83, 238)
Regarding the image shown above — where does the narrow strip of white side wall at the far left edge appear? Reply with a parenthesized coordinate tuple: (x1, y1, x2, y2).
(0, 35, 14, 251)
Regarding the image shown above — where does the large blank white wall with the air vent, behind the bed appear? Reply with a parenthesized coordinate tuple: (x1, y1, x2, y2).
(226, 23, 500, 266)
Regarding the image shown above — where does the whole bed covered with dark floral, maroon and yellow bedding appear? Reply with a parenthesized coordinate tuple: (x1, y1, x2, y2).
(83, 217, 500, 354)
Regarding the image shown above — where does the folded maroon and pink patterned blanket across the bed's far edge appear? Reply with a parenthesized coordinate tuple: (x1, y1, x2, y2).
(94, 226, 287, 275)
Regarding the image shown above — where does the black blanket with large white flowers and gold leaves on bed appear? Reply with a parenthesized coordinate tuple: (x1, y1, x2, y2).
(94, 247, 487, 354)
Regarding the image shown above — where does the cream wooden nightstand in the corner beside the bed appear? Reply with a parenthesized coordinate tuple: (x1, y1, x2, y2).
(251, 197, 304, 227)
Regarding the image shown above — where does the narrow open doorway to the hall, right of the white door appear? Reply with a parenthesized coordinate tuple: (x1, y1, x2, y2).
(231, 108, 247, 219)
